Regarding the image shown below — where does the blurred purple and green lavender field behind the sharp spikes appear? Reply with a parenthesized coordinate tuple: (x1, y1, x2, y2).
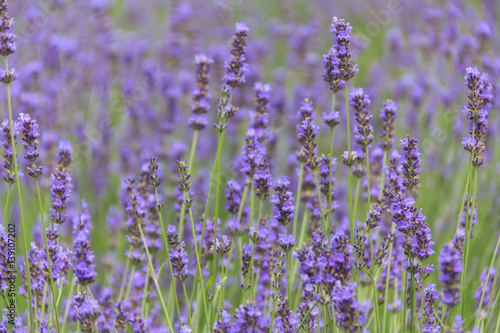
(0, 0, 500, 308)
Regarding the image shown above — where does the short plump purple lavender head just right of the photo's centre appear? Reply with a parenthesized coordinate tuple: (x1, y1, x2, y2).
(271, 176, 295, 227)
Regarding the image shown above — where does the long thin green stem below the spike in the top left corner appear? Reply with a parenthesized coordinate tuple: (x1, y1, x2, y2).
(4, 57, 35, 328)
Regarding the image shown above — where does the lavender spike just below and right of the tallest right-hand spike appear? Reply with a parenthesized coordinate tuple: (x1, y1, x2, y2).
(349, 88, 373, 150)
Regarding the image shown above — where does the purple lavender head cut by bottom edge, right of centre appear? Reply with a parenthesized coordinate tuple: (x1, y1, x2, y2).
(332, 282, 366, 332)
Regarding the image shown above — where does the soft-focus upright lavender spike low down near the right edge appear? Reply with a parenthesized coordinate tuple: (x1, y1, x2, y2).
(439, 244, 463, 307)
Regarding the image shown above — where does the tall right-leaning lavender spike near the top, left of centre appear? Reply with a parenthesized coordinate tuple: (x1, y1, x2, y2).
(222, 23, 249, 88)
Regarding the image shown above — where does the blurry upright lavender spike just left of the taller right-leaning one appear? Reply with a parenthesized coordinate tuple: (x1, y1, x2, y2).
(189, 54, 214, 130)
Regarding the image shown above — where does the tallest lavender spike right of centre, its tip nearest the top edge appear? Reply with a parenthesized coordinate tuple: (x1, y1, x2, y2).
(330, 17, 358, 81)
